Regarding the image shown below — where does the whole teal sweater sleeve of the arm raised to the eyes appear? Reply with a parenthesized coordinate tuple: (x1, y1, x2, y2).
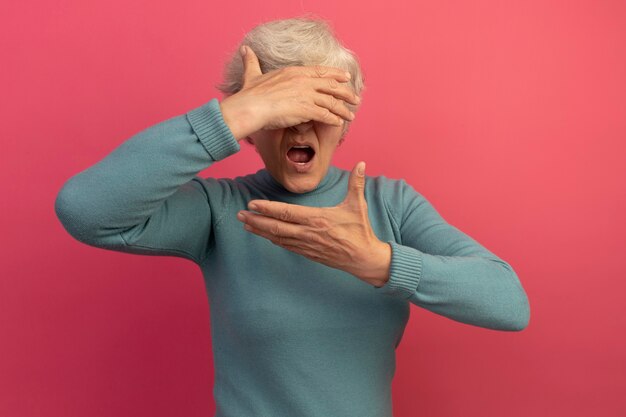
(55, 98, 240, 264)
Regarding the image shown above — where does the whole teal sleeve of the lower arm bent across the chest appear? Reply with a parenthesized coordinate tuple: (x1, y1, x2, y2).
(375, 180, 530, 331)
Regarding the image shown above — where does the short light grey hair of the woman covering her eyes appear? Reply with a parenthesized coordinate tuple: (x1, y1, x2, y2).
(215, 13, 365, 141)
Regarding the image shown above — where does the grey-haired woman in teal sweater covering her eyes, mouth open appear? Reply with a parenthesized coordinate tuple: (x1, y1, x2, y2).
(55, 17, 529, 417)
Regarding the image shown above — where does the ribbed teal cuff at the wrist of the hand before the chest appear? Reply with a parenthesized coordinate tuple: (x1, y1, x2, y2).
(374, 241, 422, 299)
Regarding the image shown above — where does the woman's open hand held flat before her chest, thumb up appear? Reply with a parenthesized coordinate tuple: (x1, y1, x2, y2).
(237, 162, 391, 287)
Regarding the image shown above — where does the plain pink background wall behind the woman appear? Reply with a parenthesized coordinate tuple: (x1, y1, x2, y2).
(0, 0, 626, 417)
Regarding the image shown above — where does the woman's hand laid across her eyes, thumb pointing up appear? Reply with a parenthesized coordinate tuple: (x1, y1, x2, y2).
(220, 46, 360, 140)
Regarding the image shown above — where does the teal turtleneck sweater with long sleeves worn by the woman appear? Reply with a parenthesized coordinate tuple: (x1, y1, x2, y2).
(55, 99, 530, 417)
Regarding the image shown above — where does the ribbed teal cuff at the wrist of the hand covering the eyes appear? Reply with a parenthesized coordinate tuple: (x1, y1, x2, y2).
(187, 98, 241, 161)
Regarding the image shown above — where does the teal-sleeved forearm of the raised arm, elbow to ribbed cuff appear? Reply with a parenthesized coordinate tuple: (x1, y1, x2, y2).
(55, 100, 239, 244)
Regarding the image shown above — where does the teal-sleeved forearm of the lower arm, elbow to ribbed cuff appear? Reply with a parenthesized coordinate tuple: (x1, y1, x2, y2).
(382, 243, 530, 331)
